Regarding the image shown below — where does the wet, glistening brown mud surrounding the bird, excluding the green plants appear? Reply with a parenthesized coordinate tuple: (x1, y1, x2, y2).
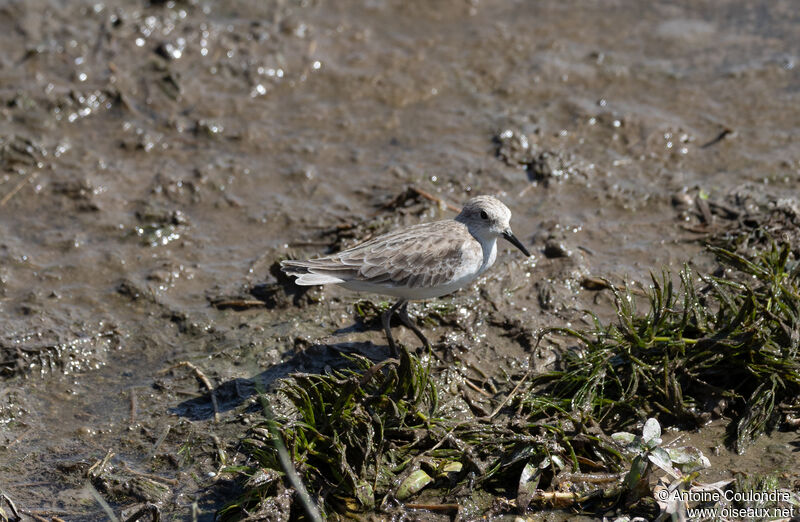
(0, 0, 800, 520)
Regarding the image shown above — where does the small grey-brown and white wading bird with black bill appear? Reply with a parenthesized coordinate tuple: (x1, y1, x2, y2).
(281, 196, 531, 355)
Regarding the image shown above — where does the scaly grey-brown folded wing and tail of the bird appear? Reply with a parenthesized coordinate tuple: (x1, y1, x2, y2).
(282, 217, 468, 288)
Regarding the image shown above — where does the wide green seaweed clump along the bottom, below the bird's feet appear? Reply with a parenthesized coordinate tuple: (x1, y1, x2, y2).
(219, 350, 624, 520)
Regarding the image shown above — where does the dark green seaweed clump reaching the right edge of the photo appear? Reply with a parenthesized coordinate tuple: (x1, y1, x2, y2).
(523, 244, 800, 454)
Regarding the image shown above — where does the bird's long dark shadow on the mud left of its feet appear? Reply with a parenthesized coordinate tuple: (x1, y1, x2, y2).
(170, 342, 390, 421)
